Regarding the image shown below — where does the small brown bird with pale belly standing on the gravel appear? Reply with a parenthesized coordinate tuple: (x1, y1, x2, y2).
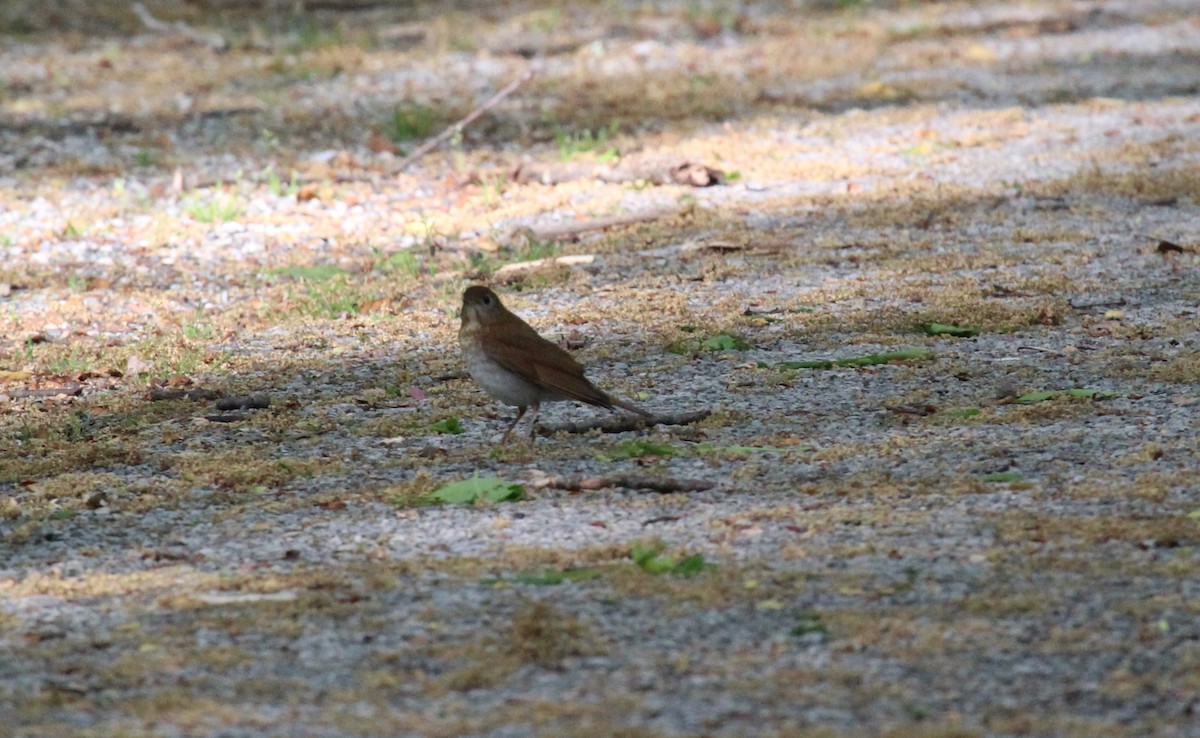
(458, 284, 653, 444)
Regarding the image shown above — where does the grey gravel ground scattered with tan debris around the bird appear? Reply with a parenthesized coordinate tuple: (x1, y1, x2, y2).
(0, 1, 1200, 738)
